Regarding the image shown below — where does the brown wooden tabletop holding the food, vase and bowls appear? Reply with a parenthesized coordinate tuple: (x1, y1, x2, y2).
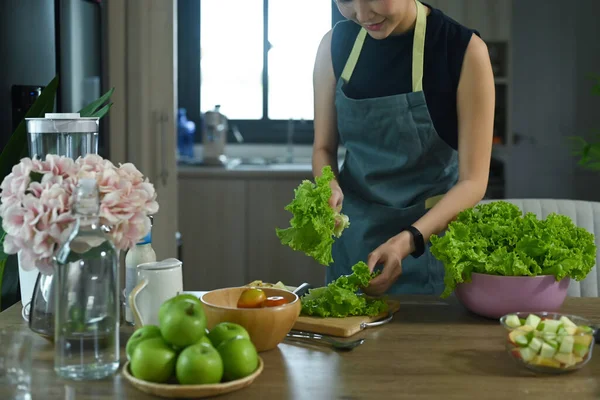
(0, 296, 600, 400)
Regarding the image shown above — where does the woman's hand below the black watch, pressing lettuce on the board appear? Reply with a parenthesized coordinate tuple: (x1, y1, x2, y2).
(363, 232, 412, 296)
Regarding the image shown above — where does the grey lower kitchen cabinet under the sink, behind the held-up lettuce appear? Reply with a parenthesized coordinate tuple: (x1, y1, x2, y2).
(179, 171, 326, 290)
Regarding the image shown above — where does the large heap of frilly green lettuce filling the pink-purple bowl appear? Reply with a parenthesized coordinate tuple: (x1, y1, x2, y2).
(431, 201, 596, 297)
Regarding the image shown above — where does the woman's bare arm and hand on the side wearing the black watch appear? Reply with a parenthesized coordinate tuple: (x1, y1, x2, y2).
(365, 35, 495, 295)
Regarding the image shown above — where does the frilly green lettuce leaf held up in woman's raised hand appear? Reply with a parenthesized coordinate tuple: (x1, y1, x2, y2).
(276, 166, 350, 265)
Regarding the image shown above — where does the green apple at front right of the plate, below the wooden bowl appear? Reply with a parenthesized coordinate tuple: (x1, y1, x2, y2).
(217, 336, 258, 381)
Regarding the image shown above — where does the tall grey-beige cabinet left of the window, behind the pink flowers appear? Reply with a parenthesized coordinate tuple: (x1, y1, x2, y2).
(106, 0, 178, 288)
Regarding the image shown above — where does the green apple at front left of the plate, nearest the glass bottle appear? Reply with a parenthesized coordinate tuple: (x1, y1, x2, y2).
(131, 337, 177, 383)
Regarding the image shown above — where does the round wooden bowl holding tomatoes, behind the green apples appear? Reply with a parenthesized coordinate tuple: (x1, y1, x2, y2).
(201, 287, 302, 352)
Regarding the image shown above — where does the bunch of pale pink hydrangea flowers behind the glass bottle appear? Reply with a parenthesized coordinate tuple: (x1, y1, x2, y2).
(0, 154, 159, 273)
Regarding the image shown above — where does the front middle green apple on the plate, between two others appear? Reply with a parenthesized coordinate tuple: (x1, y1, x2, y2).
(175, 342, 223, 385)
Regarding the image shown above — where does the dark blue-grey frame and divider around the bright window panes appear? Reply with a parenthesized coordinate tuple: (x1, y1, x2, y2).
(178, 0, 345, 144)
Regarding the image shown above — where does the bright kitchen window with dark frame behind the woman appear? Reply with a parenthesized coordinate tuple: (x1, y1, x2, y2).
(189, 0, 342, 143)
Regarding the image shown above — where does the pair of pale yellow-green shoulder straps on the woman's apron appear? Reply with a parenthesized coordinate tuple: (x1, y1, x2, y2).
(341, 0, 427, 92)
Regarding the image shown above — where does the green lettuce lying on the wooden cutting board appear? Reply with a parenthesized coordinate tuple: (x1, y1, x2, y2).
(301, 261, 388, 318)
